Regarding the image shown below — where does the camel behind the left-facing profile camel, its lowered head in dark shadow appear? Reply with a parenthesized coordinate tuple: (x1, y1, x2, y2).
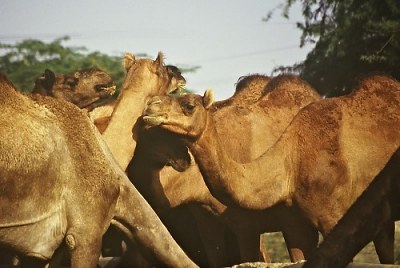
(128, 75, 319, 261)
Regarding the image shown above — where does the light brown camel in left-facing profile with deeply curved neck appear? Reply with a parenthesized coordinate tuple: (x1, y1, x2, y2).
(144, 75, 400, 262)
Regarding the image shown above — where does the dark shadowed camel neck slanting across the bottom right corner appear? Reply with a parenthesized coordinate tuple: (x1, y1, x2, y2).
(304, 150, 400, 268)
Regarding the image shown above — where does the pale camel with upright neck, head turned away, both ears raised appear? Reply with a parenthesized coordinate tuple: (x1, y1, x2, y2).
(102, 52, 173, 170)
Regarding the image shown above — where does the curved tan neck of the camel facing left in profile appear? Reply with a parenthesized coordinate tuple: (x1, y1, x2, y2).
(189, 114, 294, 209)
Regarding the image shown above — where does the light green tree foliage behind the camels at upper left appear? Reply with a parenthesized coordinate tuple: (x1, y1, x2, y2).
(0, 36, 199, 91)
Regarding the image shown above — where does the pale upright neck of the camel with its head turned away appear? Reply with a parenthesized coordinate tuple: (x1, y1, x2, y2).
(103, 90, 147, 170)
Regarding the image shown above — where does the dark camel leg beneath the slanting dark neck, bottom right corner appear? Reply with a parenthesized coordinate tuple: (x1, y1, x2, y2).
(373, 221, 394, 264)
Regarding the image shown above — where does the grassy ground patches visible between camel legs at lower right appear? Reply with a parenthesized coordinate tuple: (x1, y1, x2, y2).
(264, 222, 400, 264)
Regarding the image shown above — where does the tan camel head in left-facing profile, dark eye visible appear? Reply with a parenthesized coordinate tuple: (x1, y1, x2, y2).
(143, 90, 214, 138)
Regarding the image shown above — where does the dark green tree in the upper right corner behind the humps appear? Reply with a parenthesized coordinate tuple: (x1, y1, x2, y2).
(267, 0, 400, 96)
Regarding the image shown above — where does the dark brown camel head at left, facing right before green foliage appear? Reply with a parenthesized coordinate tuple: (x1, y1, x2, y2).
(32, 68, 116, 111)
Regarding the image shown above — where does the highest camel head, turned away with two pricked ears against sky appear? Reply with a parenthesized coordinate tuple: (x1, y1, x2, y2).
(122, 52, 176, 96)
